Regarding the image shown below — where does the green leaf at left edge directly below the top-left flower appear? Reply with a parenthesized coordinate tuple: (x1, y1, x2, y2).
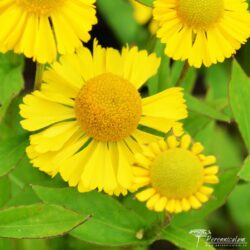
(0, 52, 24, 121)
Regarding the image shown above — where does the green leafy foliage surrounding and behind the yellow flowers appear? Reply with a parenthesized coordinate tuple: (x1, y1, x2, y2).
(0, 0, 250, 250)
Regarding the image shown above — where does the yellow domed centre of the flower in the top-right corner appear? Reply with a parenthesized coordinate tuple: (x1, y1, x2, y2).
(177, 0, 224, 28)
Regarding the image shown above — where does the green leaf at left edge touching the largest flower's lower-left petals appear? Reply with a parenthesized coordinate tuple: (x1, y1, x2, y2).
(0, 136, 28, 177)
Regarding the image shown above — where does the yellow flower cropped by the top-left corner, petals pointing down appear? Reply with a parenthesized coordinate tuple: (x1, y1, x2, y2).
(0, 0, 97, 63)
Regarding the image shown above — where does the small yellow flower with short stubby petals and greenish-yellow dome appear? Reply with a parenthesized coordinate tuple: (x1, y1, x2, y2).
(133, 134, 219, 213)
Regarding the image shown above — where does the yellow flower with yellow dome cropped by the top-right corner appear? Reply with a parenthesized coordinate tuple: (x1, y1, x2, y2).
(153, 0, 250, 68)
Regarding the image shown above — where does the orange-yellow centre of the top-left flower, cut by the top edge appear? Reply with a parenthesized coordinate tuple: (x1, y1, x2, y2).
(16, 0, 65, 15)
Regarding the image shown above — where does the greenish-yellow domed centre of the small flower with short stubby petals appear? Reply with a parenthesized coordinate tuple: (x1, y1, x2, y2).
(151, 148, 203, 198)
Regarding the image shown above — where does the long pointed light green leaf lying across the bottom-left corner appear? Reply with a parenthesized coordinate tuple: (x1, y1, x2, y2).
(0, 204, 86, 239)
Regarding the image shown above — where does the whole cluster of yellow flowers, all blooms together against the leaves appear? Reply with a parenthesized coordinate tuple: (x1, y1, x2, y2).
(0, 0, 250, 213)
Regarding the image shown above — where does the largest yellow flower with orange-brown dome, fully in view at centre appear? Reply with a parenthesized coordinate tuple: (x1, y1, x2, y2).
(20, 43, 187, 195)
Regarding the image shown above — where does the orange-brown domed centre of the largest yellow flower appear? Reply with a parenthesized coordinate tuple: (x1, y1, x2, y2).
(75, 73, 142, 142)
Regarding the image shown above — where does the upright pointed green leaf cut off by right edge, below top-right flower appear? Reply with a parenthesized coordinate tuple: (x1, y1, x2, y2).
(229, 61, 250, 152)
